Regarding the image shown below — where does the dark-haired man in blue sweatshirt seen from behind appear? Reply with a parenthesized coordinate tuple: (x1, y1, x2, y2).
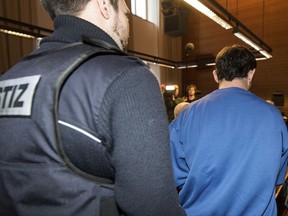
(170, 45, 288, 216)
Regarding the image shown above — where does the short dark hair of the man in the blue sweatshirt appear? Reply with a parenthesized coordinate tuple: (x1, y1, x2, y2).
(215, 45, 257, 81)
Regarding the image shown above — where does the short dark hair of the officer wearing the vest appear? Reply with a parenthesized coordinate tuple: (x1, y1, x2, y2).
(40, 0, 119, 20)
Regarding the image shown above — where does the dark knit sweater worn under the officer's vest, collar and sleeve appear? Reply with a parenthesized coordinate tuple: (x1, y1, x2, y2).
(40, 16, 184, 216)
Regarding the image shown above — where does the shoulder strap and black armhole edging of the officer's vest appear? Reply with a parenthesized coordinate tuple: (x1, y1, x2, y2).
(29, 38, 126, 184)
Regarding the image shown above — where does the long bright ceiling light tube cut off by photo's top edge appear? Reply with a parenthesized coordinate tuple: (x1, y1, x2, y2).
(184, 0, 232, 30)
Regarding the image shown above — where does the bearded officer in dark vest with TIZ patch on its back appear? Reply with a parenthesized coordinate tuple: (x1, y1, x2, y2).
(0, 0, 185, 216)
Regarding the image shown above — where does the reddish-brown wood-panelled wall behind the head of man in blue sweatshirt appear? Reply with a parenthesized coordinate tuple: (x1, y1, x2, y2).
(183, 0, 288, 114)
